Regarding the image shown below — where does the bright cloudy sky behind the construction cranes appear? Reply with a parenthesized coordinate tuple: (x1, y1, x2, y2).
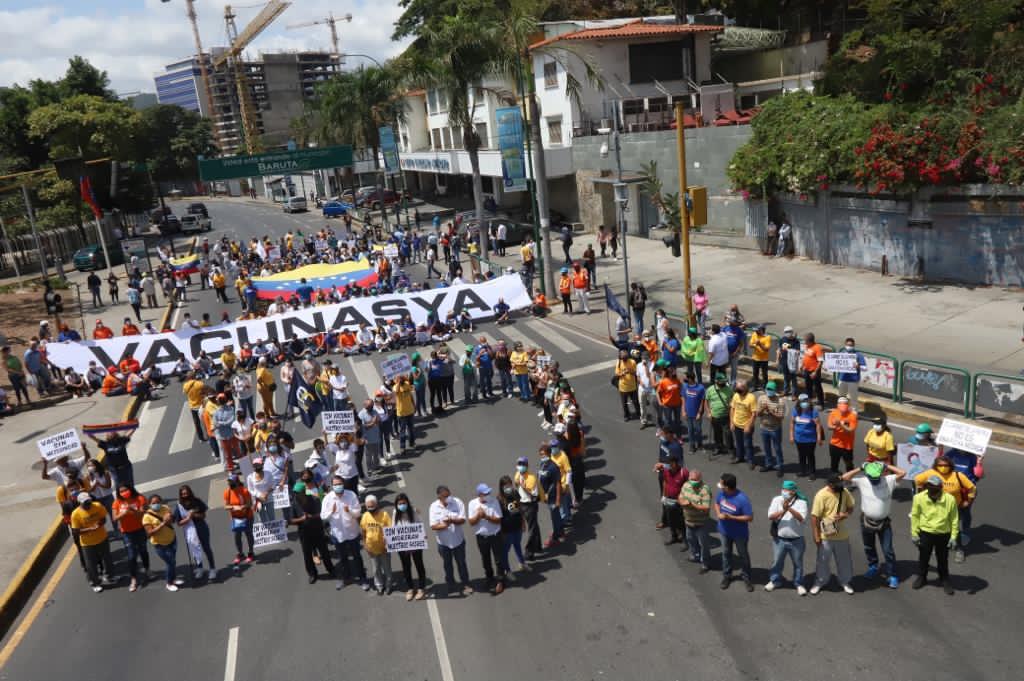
(0, 0, 403, 92)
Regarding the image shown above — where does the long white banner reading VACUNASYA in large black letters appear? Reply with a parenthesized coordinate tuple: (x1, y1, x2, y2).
(46, 274, 530, 374)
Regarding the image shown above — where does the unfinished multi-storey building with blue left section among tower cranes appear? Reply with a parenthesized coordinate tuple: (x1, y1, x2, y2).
(154, 47, 341, 156)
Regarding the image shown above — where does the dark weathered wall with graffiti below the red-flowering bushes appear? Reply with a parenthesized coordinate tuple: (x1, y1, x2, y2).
(771, 187, 1024, 286)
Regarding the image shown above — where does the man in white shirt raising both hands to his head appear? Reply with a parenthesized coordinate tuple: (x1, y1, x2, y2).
(843, 461, 906, 589)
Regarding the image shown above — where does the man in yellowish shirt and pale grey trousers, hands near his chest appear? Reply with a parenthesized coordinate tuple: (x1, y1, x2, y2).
(811, 475, 855, 596)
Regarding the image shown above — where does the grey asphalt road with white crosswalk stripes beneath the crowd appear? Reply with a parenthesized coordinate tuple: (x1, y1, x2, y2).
(0, 197, 1024, 681)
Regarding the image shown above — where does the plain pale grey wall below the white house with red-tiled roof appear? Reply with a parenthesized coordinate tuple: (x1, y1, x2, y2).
(572, 126, 751, 235)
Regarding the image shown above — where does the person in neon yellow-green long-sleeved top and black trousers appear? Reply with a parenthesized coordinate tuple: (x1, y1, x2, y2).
(910, 473, 959, 596)
